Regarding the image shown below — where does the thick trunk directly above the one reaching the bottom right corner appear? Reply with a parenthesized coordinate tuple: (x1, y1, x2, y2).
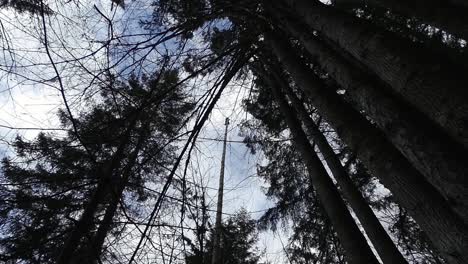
(270, 17, 468, 223)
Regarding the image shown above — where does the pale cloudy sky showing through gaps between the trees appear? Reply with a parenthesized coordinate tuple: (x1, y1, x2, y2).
(0, 0, 287, 263)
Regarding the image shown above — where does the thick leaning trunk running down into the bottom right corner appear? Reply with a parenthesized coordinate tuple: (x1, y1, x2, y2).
(265, 33, 468, 264)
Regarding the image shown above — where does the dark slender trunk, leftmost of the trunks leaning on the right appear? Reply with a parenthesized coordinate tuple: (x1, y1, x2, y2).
(258, 64, 378, 264)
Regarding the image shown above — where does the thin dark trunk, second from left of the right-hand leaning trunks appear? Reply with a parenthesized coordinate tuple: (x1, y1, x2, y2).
(275, 75, 408, 264)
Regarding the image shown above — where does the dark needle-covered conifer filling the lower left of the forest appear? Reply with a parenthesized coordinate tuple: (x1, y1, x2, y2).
(1, 70, 193, 263)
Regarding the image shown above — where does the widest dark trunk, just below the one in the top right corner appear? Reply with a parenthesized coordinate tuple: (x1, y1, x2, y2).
(276, 0, 468, 148)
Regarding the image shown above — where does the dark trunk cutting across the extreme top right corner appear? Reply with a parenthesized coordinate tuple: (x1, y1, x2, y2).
(333, 0, 468, 40)
